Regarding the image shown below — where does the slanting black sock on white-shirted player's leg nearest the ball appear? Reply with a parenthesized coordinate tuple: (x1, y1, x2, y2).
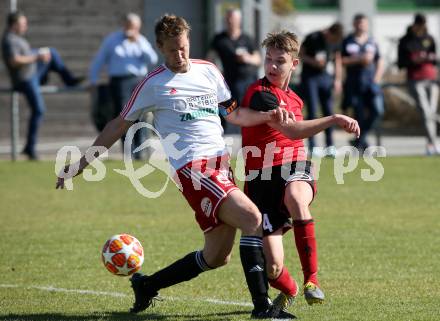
(148, 251, 211, 292)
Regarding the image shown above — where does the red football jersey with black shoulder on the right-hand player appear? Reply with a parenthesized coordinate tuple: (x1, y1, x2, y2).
(241, 78, 307, 170)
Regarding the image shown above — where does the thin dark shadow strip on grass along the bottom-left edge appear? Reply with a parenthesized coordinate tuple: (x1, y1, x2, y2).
(0, 311, 250, 321)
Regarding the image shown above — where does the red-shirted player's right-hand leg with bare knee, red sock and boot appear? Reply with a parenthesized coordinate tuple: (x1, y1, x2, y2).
(284, 181, 324, 304)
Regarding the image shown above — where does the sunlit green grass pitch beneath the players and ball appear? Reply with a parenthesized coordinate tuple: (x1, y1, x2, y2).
(0, 157, 440, 321)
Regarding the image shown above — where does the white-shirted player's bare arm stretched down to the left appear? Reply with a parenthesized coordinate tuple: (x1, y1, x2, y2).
(56, 116, 133, 189)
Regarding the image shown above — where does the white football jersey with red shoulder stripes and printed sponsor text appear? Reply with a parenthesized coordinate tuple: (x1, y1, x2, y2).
(121, 59, 231, 170)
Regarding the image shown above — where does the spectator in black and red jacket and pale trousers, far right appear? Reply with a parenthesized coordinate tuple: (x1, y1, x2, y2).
(398, 14, 440, 155)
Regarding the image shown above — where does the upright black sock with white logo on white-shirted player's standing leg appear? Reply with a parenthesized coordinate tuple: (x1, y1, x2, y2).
(240, 236, 269, 311)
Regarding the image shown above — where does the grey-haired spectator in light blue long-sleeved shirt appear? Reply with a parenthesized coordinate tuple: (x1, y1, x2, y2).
(89, 13, 158, 159)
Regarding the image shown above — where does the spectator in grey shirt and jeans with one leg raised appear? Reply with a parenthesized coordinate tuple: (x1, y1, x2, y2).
(2, 12, 81, 160)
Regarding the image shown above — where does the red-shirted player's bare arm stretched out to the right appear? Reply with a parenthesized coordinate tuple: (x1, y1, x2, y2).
(269, 114, 361, 139)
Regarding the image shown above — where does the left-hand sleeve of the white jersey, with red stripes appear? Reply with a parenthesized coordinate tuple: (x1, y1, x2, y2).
(121, 79, 156, 121)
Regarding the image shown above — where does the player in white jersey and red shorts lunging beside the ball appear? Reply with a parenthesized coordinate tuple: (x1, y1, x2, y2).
(57, 15, 294, 319)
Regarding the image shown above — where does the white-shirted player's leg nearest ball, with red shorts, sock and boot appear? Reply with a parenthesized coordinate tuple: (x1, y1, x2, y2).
(131, 160, 241, 313)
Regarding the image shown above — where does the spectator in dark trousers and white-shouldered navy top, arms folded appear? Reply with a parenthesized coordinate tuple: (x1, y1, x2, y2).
(342, 14, 384, 151)
